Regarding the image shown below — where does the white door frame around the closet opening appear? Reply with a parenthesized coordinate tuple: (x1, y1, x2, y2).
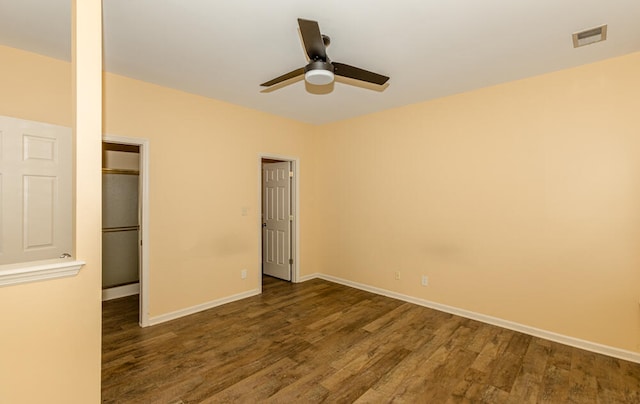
(102, 134, 151, 327)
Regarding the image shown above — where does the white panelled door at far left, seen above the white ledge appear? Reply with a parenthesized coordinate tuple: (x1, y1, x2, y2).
(0, 116, 72, 264)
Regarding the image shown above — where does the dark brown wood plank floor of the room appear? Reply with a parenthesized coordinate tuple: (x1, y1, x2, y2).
(102, 277, 640, 403)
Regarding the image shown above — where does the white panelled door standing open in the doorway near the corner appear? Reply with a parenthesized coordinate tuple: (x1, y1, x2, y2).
(262, 162, 293, 281)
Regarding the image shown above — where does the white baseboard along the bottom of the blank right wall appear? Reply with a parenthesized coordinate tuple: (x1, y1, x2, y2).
(304, 274, 640, 363)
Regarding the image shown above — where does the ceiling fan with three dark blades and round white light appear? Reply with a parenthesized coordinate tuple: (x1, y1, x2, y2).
(260, 18, 389, 87)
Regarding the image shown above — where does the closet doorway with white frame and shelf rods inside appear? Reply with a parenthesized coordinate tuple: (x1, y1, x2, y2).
(102, 135, 149, 327)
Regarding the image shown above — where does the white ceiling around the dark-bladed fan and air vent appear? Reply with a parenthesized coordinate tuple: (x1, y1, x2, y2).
(0, 0, 640, 124)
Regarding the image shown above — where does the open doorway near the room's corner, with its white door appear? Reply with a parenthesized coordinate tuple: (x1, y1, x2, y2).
(260, 154, 300, 282)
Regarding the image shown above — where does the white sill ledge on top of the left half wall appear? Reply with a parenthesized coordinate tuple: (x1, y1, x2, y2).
(0, 259, 85, 286)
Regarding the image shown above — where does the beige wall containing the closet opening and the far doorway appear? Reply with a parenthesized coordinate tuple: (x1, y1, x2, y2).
(104, 74, 317, 317)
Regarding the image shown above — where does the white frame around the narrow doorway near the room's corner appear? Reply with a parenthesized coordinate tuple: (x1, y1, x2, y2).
(256, 153, 300, 293)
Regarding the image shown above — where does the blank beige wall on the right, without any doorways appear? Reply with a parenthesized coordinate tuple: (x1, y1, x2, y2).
(315, 53, 640, 351)
